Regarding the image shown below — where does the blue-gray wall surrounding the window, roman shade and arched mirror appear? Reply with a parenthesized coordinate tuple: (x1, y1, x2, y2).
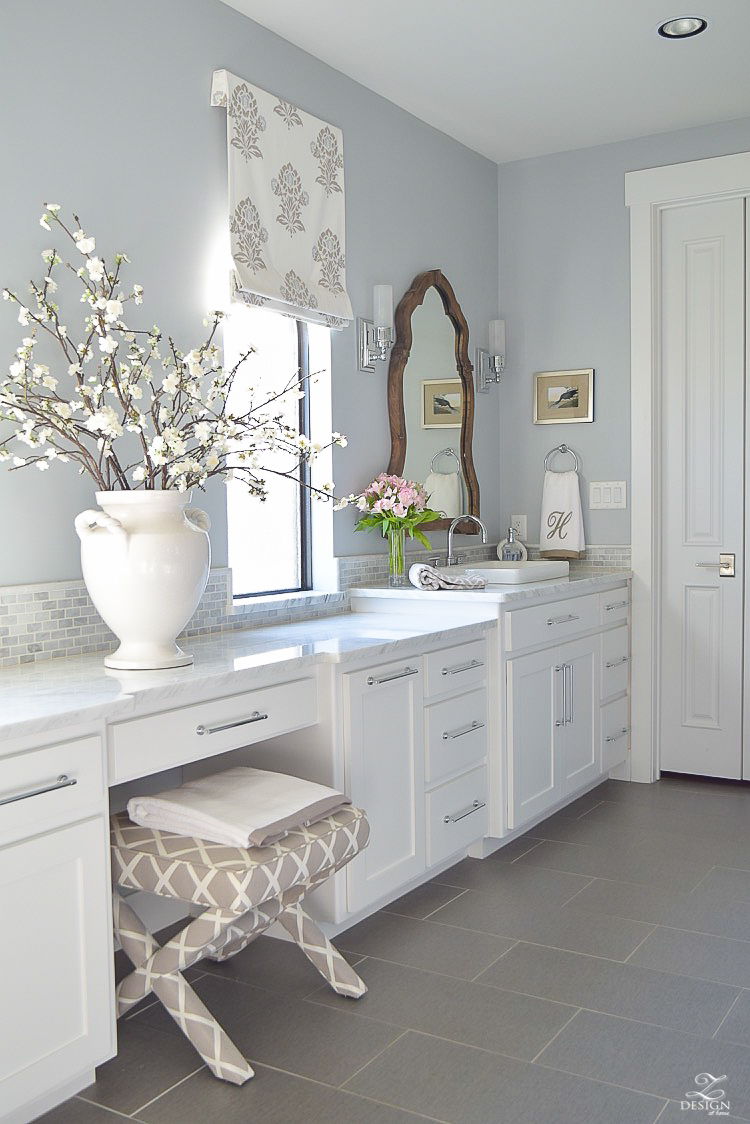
(0, 0, 499, 584)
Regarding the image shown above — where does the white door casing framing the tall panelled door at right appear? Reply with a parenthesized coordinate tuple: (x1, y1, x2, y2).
(625, 153, 750, 781)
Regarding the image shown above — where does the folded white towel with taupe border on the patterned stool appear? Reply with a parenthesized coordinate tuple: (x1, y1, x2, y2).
(127, 765, 352, 847)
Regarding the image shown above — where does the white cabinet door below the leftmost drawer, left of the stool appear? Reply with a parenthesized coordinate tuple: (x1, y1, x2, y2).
(0, 817, 115, 1120)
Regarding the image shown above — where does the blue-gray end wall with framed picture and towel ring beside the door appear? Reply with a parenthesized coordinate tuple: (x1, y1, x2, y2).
(501, 119, 750, 544)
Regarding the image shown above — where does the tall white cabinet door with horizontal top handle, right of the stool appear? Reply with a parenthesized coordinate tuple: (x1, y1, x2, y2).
(343, 659, 425, 913)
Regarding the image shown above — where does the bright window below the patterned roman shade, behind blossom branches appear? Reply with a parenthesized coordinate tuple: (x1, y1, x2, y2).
(224, 305, 331, 598)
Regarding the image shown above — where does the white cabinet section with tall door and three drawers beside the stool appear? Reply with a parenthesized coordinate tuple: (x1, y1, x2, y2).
(344, 637, 488, 919)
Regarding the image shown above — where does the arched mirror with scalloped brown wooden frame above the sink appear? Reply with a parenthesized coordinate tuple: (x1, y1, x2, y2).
(388, 270, 479, 535)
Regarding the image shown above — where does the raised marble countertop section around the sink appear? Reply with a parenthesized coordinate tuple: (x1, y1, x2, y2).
(350, 569, 631, 616)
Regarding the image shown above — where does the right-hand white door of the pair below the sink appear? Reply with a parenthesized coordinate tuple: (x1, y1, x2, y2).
(557, 636, 602, 796)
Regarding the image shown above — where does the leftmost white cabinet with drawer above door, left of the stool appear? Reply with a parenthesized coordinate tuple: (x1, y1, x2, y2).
(0, 734, 116, 1124)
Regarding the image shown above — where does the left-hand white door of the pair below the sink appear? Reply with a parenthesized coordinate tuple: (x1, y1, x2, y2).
(507, 649, 563, 827)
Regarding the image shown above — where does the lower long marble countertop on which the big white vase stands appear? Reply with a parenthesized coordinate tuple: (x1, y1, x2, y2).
(0, 611, 491, 743)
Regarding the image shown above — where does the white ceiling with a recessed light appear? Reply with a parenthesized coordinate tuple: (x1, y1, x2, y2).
(224, 0, 750, 163)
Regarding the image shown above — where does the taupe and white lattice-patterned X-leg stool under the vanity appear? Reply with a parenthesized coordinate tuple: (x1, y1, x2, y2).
(111, 807, 370, 1085)
